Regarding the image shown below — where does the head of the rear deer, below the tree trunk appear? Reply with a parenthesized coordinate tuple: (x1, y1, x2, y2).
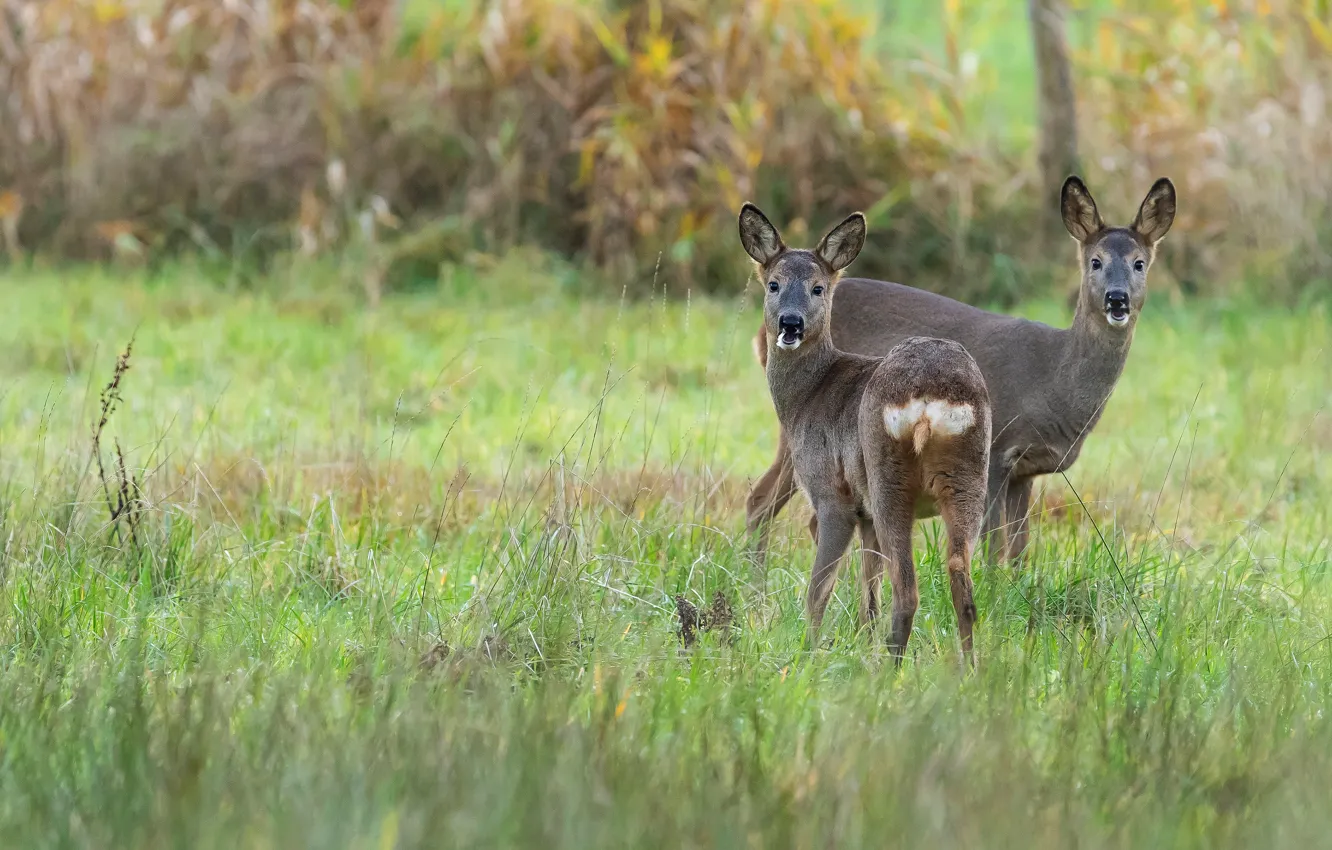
(1060, 177, 1175, 332)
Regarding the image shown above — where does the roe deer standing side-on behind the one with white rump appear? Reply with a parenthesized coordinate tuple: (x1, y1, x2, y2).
(746, 177, 1175, 562)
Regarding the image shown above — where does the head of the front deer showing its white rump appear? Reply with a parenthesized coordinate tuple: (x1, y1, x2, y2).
(739, 204, 864, 352)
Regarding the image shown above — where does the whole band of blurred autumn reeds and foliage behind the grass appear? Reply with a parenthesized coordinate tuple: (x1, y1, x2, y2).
(0, 0, 1332, 300)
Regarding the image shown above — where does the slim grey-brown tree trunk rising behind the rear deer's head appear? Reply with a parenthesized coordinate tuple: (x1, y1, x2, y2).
(1027, 0, 1078, 233)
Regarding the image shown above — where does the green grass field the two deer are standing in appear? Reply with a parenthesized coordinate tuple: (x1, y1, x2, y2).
(0, 256, 1332, 847)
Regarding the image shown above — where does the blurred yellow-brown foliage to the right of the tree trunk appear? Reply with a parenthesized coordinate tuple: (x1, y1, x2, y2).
(1078, 0, 1332, 300)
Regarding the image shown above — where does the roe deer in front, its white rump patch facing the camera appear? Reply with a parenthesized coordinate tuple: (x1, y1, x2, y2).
(739, 204, 990, 663)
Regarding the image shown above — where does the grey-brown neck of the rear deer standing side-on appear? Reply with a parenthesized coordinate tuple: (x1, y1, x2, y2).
(1056, 296, 1136, 436)
